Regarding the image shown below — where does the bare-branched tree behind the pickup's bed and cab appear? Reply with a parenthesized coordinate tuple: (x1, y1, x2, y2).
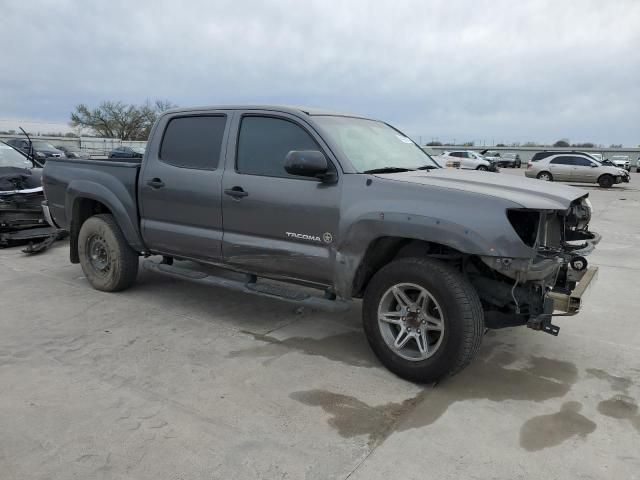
(70, 100, 175, 140)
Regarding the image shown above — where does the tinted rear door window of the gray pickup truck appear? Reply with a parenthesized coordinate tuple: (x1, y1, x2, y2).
(160, 115, 227, 170)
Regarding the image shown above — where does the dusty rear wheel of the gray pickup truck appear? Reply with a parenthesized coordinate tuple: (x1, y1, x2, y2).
(78, 214, 138, 292)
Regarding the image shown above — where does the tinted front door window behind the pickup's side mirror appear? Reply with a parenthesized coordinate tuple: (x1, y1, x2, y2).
(236, 116, 320, 178)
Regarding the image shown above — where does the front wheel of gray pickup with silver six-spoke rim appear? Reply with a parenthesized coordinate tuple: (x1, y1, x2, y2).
(362, 257, 484, 383)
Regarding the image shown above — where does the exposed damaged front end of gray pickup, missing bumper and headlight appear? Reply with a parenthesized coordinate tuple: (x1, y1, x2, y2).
(469, 195, 600, 335)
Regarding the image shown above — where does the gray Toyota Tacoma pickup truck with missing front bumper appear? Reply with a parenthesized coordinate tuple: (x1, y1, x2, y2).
(43, 106, 599, 382)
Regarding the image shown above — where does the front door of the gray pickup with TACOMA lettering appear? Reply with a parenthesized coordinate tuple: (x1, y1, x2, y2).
(222, 112, 341, 285)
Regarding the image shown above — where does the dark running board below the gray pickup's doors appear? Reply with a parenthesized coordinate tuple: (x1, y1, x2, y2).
(142, 260, 351, 312)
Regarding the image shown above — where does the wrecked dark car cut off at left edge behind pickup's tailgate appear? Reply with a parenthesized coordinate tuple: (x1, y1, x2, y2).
(0, 142, 61, 253)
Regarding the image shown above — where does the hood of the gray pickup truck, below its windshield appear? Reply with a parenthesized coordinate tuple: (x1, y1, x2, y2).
(376, 168, 588, 210)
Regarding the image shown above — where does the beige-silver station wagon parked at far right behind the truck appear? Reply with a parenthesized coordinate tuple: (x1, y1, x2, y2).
(525, 153, 629, 188)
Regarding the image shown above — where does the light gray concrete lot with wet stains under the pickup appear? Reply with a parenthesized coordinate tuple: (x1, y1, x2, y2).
(0, 170, 640, 480)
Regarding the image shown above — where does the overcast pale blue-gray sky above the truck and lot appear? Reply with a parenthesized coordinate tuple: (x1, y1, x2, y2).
(0, 0, 640, 146)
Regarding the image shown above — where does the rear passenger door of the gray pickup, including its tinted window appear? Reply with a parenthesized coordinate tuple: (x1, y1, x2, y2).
(138, 111, 229, 261)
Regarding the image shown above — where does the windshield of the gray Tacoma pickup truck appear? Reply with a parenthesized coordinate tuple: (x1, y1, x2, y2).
(315, 115, 440, 173)
